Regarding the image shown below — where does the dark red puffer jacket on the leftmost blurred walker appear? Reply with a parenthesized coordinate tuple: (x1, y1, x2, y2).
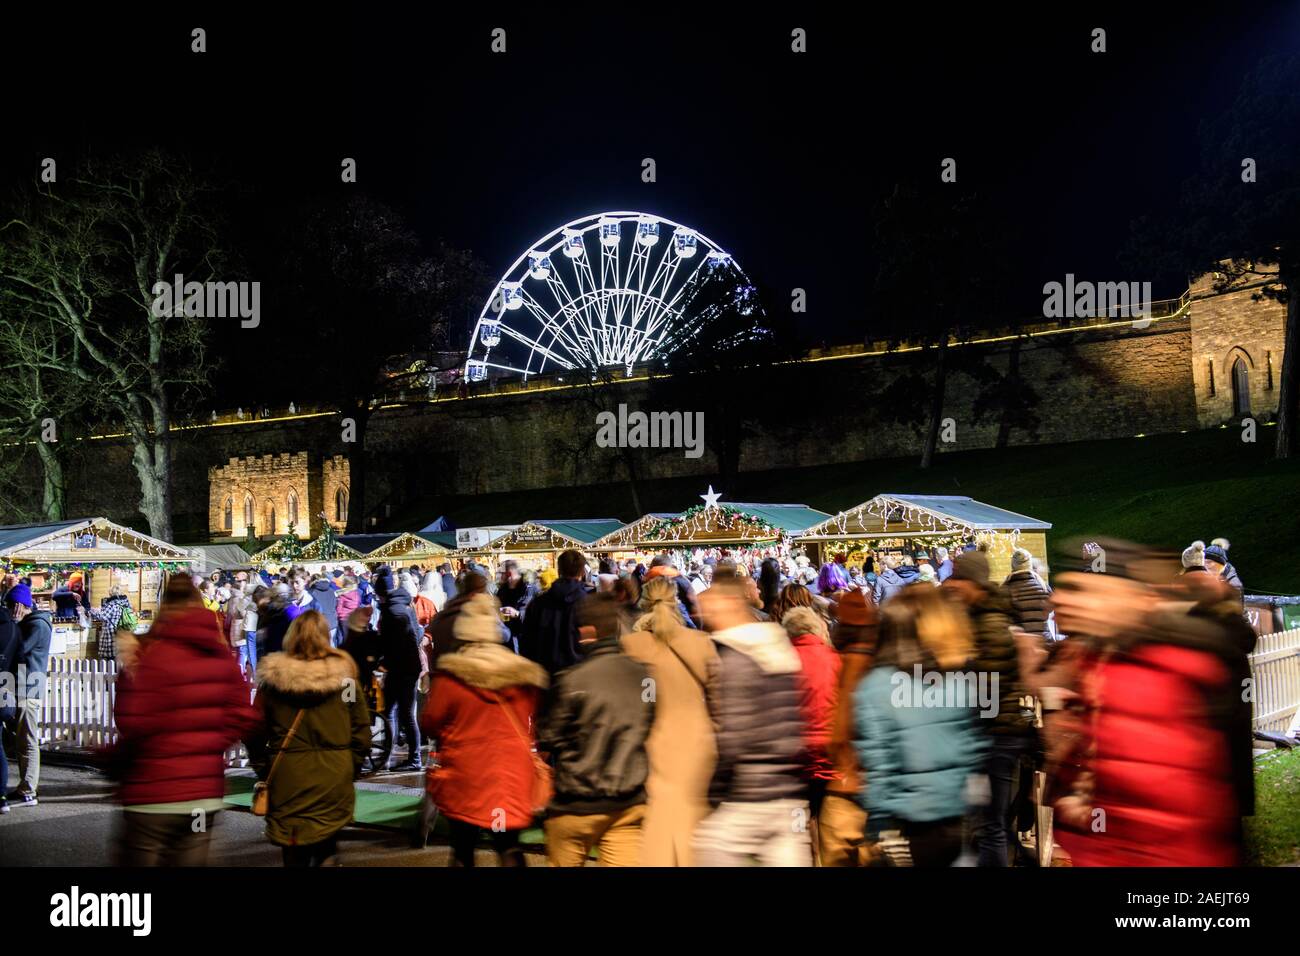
(113, 606, 260, 806)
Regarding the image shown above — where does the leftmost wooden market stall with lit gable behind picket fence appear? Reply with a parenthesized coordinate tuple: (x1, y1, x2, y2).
(0, 518, 194, 658)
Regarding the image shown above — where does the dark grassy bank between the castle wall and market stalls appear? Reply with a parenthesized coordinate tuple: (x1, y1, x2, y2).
(389, 428, 1300, 594)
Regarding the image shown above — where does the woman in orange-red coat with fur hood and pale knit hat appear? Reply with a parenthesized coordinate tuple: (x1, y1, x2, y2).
(420, 593, 547, 866)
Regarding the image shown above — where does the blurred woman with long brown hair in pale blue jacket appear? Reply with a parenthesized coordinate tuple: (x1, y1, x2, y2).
(854, 582, 987, 866)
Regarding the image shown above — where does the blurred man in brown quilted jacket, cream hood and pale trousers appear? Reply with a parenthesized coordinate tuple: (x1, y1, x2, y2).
(694, 568, 813, 866)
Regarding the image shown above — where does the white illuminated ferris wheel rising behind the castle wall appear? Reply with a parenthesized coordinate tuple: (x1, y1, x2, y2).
(465, 212, 762, 381)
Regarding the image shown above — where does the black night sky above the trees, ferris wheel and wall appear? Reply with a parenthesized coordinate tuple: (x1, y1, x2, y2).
(0, 4, 1300, 341)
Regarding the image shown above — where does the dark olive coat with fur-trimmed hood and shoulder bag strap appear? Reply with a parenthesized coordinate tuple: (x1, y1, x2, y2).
(248, 652, 371, 847)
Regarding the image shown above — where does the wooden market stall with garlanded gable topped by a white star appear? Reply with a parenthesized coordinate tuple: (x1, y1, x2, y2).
(592, 502, 831, 564)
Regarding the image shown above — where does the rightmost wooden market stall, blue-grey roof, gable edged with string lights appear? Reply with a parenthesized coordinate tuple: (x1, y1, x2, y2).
(798, 494, 1052, 581)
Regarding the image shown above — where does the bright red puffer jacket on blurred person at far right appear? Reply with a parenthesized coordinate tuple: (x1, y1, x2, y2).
(1057, 644, 1239, 866)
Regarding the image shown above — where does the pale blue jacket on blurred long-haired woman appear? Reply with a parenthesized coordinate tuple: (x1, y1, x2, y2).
(853, 665, 985, 835)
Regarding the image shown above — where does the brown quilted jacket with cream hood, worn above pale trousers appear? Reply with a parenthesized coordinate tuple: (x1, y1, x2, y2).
(709, 622, 806, 806)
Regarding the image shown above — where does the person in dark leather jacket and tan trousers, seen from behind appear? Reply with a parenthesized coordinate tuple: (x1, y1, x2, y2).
(538, 590, 655, 866)
